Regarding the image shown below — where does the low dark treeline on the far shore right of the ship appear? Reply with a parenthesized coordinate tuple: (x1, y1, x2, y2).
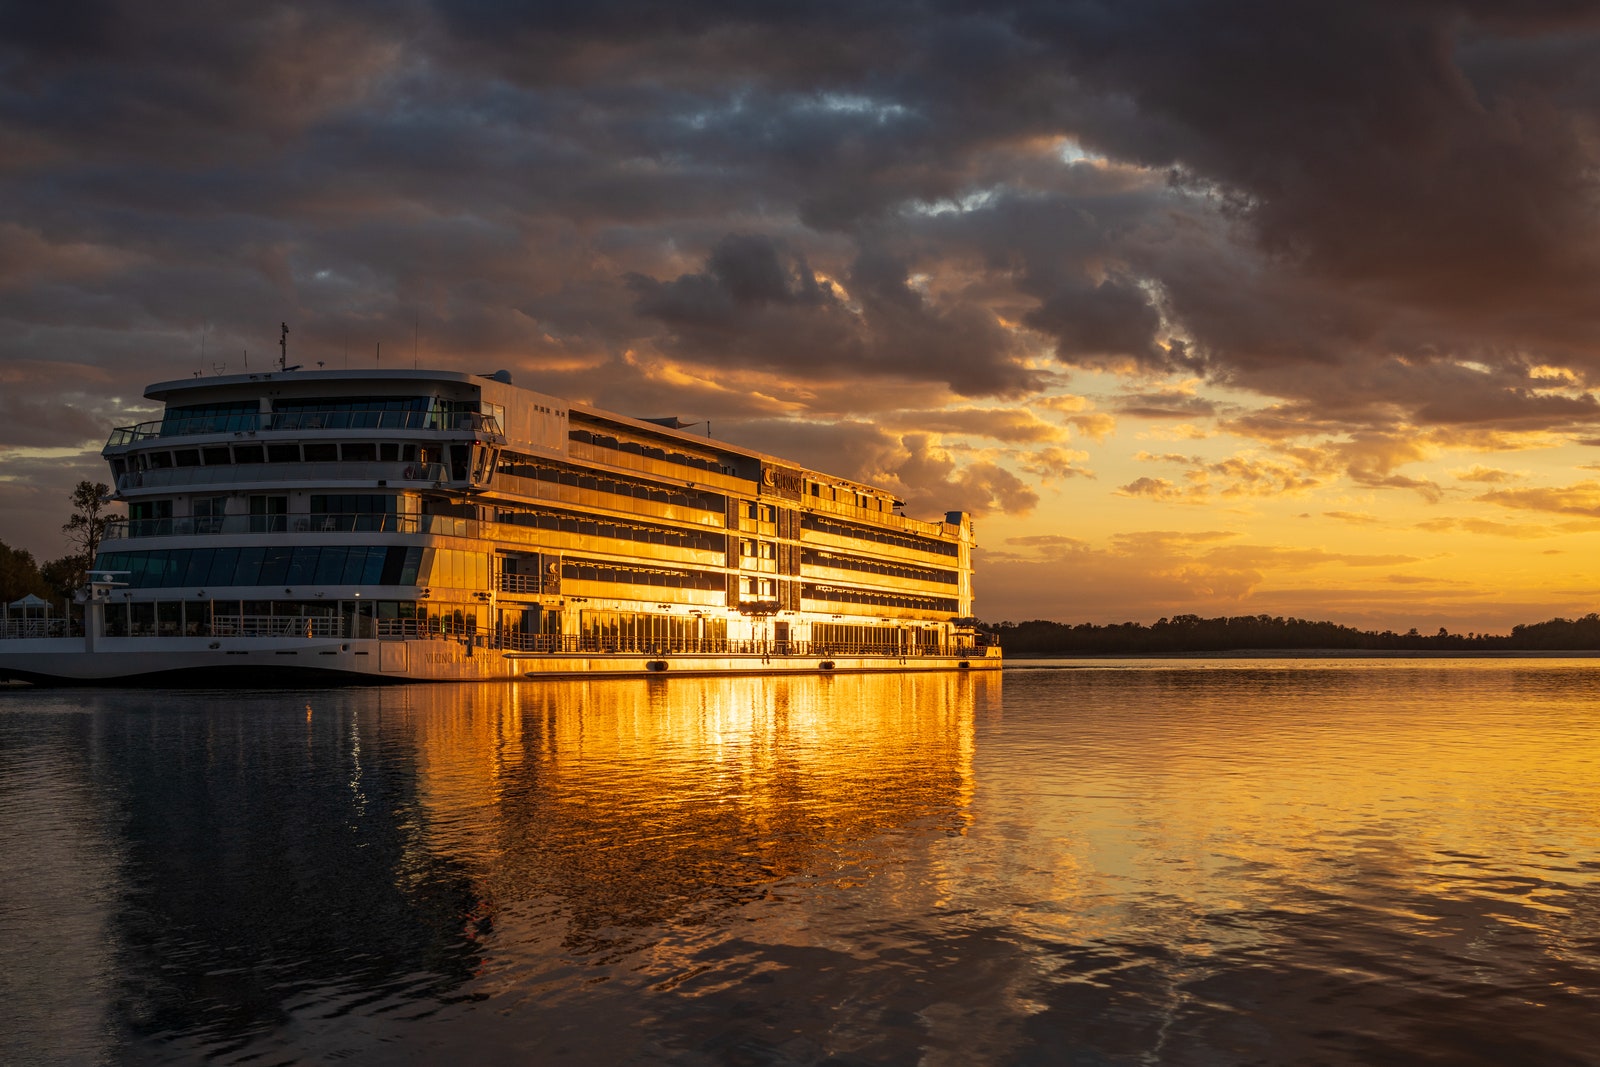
(984, 614, 1600, 656)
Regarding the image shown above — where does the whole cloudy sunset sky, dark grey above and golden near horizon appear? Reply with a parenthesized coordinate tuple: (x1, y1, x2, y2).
(0, 0, 1600, 632)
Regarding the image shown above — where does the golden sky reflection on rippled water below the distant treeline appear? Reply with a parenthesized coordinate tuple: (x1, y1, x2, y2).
(979, 661, 1600, 971)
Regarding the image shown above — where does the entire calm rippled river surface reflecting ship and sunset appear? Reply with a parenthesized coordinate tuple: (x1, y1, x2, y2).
(0, 659, 1600, 1065)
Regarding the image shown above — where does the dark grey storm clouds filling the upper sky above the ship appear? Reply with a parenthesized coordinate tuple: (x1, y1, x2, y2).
(0, 0, 1600, 559)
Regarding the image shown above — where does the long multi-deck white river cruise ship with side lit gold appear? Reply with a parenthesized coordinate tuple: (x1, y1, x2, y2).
(0, 368, 1000, 685)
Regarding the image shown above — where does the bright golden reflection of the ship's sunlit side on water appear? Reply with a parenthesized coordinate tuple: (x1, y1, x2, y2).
(400, 673, 1000, 947)
